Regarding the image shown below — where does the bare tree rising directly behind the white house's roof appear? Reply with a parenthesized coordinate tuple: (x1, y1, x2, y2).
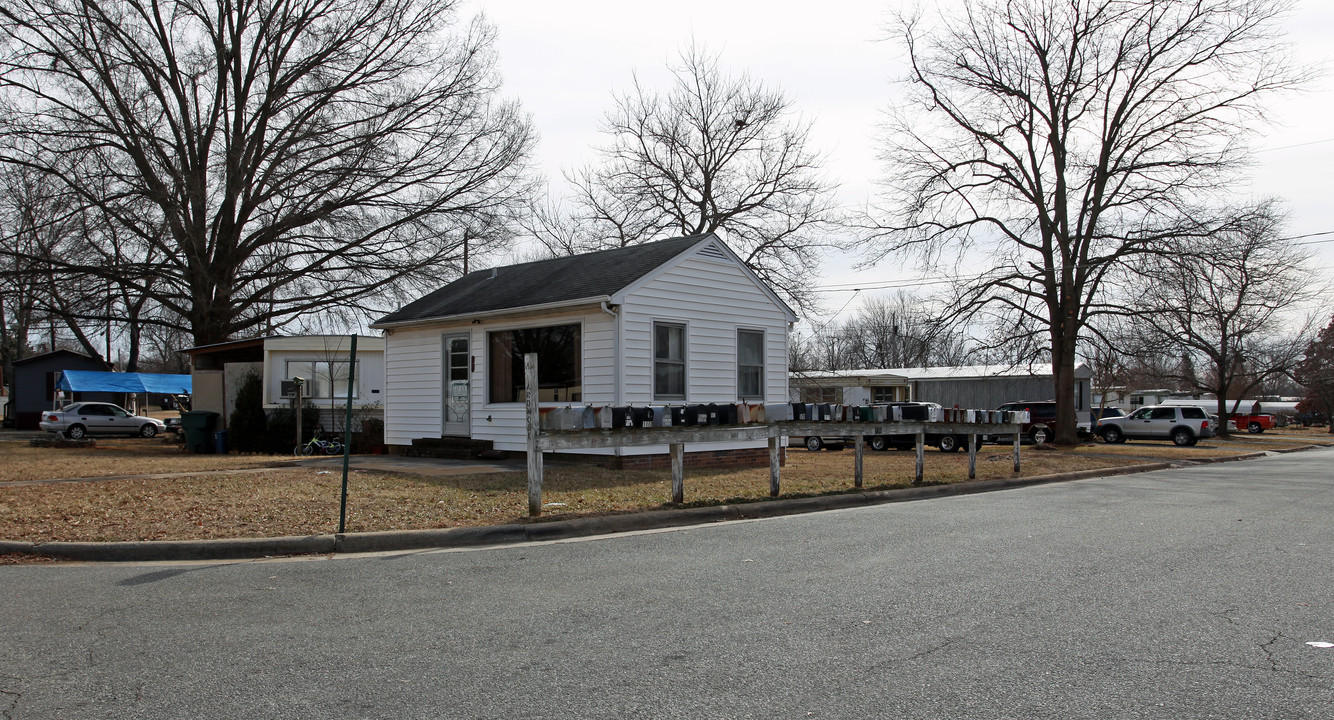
(552, 47, 838, 314)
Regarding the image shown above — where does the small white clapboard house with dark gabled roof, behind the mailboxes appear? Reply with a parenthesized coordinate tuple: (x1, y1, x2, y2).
(371, 233, 796, 467)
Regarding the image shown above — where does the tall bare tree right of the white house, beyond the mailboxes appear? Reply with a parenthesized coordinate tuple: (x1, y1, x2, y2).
(872, 0, 1301, 443)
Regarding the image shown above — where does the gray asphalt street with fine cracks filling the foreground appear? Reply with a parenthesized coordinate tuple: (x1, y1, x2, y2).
(0, 449, 1334, 720)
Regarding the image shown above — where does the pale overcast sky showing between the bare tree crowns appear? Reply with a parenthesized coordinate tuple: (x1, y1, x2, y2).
(480, 0, 1334, 332)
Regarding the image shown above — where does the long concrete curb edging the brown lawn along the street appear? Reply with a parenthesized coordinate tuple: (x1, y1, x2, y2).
(0, 445, 1318, 563)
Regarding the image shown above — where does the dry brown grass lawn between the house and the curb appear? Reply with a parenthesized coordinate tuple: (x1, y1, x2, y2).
(0, 433, 1327, 543)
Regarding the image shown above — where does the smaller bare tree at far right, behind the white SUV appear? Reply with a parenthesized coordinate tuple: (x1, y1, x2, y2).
(1119, 201, 1323, 435)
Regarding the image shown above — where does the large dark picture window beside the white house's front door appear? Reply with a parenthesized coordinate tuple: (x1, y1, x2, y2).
(487, 324, 583, 403)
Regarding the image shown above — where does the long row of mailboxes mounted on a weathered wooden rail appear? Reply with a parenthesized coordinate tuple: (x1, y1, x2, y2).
(540, 403, 1029, 431)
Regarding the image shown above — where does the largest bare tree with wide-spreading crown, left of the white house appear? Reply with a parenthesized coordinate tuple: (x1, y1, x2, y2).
(0, 0, 532, 344)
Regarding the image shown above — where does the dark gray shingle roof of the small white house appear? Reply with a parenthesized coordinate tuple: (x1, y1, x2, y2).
(371, 235, 710, 327)
